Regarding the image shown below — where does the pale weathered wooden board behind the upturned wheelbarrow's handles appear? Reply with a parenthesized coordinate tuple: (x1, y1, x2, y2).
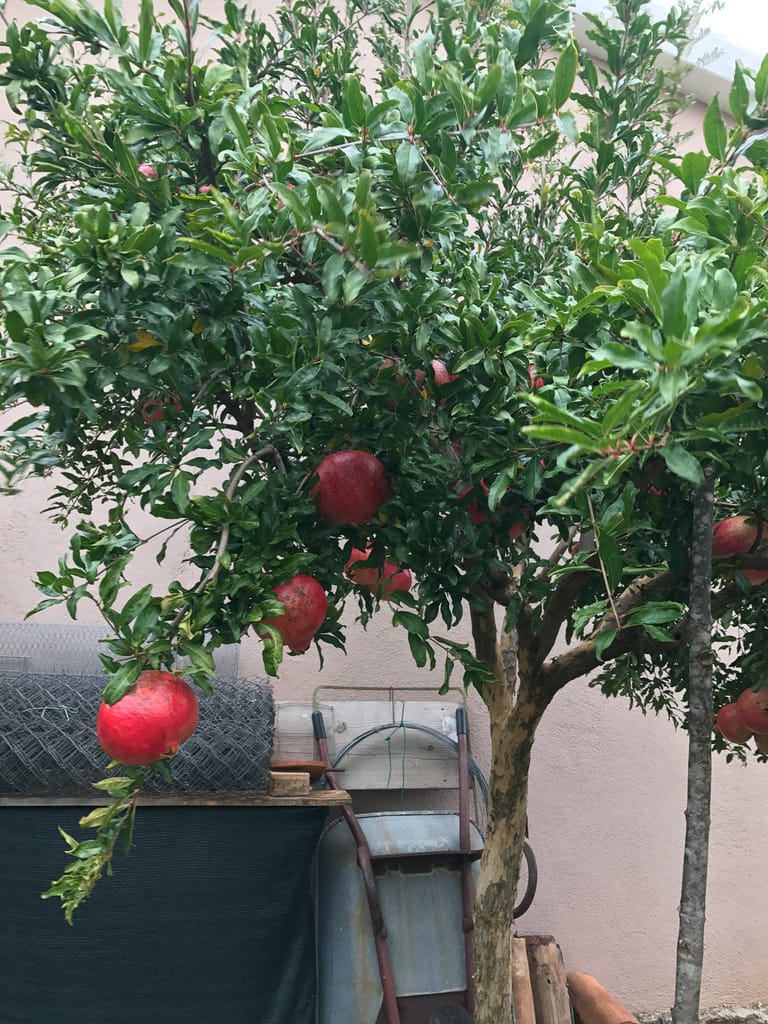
(272, 700, 466, 790)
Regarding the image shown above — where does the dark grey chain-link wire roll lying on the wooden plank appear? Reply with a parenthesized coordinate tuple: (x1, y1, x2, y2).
(0, 671, 274, 796)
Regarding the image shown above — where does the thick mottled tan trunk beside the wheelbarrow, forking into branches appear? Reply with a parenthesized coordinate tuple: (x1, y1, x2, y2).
(474, 666, 544, 1024)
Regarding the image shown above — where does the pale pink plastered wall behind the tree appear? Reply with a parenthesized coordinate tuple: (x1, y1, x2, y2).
(0, 0, 768, 1011)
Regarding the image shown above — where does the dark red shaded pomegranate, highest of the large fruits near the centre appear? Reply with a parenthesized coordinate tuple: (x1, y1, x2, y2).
(309, 449, 389, 526)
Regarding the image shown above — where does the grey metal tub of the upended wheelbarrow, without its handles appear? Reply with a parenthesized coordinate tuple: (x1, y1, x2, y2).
(315, 811, 482, 1024)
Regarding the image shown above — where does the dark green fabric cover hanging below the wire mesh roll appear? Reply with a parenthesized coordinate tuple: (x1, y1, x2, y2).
(0, 807, 325, 1024)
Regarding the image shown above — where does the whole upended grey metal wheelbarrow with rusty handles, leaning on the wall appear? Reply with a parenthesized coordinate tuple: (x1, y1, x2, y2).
(312, 709, 536, 1024)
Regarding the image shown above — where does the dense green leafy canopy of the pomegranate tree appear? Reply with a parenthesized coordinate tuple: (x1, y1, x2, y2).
(0, 0, 768, 737)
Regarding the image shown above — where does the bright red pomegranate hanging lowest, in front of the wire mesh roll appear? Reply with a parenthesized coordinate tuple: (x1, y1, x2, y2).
(96, 670, 198, 765)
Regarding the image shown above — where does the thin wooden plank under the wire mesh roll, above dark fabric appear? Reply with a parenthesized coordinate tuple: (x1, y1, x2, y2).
(0, 790, 351, 808)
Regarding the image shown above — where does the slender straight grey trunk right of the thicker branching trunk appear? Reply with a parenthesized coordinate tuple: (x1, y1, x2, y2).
(672, 471, 713, 1024)
